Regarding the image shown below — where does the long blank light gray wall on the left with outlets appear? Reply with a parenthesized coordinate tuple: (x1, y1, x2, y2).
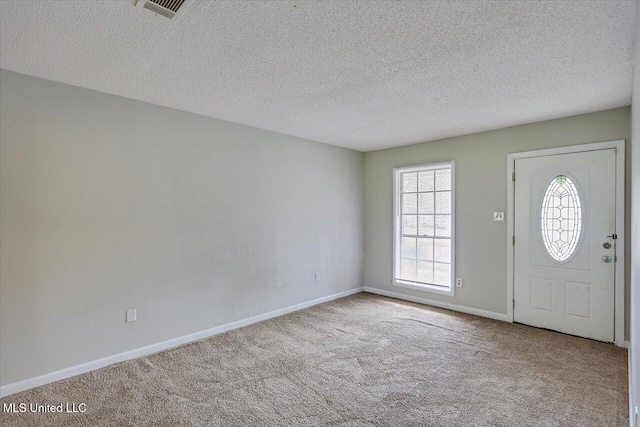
(0, 70, 363, 385)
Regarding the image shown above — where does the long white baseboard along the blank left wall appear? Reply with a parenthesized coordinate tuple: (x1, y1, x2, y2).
(0, 287, 364, 397)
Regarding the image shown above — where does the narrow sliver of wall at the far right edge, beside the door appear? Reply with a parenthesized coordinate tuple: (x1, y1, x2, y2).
(629, 7, 640, 427)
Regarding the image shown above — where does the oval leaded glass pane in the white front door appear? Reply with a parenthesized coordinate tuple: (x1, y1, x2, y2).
(540, 175, 582, 262)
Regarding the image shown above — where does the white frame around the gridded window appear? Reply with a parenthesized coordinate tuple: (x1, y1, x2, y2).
(391, 160, 456, 296)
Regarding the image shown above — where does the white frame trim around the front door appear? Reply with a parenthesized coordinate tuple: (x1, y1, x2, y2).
(507, 139, 625, 347)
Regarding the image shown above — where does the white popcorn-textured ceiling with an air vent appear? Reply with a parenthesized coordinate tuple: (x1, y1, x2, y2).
(0, 0, 636, 151)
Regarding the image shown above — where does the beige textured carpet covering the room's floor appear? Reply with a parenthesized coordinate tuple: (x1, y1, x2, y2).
(0, 294, 628, 426)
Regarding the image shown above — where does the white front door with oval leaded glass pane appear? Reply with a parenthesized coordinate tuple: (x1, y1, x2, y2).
(514, 149, 616, 342)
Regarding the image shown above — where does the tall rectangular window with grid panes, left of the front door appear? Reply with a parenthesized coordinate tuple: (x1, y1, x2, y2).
(394, 162, 454, 294)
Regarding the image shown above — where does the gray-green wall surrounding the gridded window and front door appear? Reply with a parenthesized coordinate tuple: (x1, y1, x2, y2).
(364, 107, 631, 332)
